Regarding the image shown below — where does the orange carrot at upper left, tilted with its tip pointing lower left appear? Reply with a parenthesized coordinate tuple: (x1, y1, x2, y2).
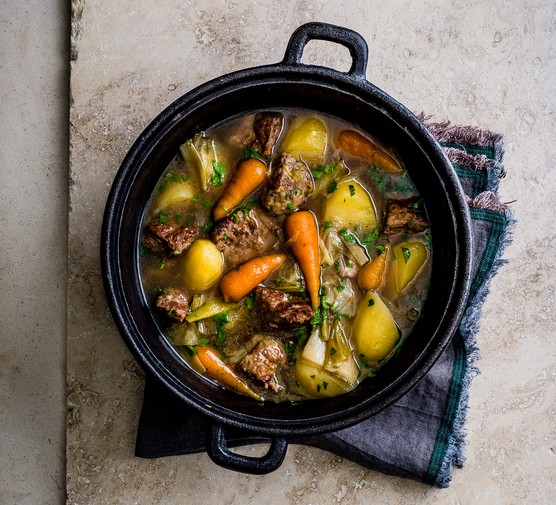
(212, 158, 267, 221)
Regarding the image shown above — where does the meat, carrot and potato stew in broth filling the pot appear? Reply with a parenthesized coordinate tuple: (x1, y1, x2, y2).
(140, 109, 432, 401)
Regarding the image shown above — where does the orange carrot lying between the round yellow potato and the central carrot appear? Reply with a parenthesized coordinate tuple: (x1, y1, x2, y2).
(220, 254, 286, 302)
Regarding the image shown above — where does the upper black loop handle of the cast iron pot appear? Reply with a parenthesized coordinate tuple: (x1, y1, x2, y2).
(282, 22, 369, 78)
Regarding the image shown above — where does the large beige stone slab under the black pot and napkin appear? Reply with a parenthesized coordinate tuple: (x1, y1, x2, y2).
(67, 0, 556, 505)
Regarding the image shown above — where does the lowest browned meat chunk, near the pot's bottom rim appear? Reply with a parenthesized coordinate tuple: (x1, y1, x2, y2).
(239, 337, 286, 392)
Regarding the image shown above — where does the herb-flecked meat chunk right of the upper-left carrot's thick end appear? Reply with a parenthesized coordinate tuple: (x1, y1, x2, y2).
(261, 153, 314, 215)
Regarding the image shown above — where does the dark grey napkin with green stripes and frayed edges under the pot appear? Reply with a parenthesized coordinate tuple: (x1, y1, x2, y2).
(136, 118, 513, 487)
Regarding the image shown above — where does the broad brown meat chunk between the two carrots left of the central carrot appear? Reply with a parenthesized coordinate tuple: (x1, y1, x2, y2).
(212, 209, 280, 265)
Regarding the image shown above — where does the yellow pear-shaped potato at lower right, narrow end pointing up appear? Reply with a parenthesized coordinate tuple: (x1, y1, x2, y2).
(352, 291, 400, 362)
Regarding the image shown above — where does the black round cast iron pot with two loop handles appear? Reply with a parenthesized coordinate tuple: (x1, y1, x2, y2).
(102, 23, 471, 474)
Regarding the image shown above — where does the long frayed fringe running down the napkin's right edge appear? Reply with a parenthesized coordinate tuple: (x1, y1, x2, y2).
(435, 203, 515, 488)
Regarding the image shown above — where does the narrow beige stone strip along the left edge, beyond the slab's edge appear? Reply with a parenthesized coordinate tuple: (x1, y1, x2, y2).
(0, 0, 69, 505)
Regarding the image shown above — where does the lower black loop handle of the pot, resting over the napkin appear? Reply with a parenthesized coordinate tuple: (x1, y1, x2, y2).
(207, 423, 288, 475)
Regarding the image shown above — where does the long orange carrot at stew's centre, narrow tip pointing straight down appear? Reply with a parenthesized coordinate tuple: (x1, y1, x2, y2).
(284, 210, 320, 309)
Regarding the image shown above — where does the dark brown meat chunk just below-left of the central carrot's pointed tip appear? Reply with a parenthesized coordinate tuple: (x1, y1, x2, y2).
(255, 286, 315, 328)
